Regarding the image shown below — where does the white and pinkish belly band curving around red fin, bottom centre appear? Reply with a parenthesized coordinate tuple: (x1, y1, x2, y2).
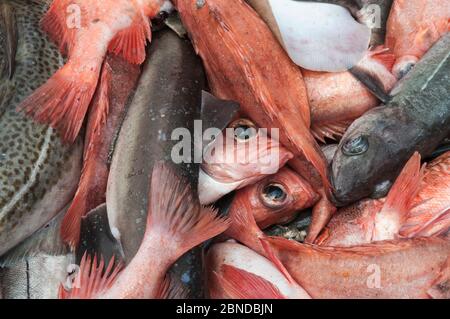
(205, 241, 310, 299)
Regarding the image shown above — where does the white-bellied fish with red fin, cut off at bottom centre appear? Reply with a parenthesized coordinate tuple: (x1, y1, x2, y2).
(205, 241, 310, 299)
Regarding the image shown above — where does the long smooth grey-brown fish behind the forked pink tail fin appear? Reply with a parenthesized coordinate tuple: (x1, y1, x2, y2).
(106, 30, 206, 296)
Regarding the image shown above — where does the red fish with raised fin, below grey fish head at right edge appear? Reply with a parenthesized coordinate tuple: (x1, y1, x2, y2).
(316, 152, 450, 246)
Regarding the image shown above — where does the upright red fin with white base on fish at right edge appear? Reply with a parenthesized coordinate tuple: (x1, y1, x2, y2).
(373, 152, 425, 241)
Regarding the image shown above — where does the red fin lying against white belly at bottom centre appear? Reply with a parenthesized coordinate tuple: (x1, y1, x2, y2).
(216, 265, 286, 299)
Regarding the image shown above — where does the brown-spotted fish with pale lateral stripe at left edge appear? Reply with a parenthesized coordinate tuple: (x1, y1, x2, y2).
(0, 0, 82, 255)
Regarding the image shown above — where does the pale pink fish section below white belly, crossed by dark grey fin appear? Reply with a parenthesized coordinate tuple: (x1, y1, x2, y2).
(302, 49, 397, 143)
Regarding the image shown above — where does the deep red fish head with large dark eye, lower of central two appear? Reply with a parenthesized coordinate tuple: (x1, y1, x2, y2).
(230, 167, 317, 229)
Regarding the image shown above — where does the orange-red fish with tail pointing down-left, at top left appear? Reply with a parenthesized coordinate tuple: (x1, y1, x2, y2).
(17, 0, 171, 143)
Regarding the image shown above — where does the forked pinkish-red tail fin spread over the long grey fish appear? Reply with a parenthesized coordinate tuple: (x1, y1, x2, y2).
(146, 162, 230, 259)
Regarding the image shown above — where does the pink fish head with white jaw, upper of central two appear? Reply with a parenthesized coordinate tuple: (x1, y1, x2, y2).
(198, 118, 294, 205)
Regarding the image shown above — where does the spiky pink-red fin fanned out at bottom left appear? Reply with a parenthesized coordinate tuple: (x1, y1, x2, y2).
(59, 253, 122, 299)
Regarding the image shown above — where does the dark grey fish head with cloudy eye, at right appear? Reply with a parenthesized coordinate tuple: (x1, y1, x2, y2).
(331, 108, 401, 206)
